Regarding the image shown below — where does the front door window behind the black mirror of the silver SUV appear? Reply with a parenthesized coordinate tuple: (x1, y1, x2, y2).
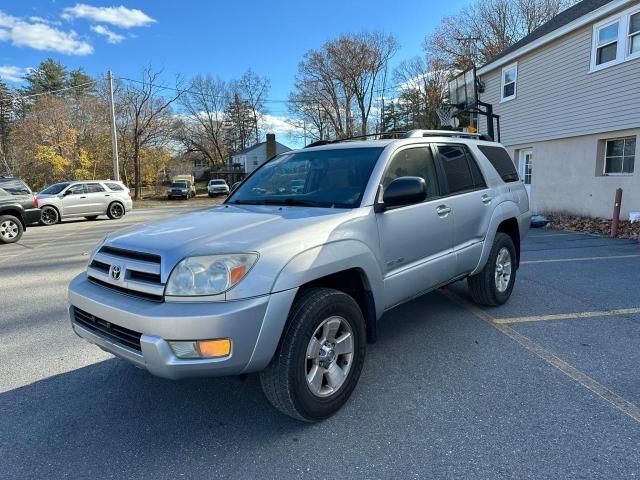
(382, 147, 440, 199)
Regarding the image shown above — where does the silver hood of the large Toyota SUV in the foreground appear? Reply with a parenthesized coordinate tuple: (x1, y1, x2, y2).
(106, 205, 353, 277)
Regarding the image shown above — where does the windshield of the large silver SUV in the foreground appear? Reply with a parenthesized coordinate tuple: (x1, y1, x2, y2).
(228, 148, 383, 208)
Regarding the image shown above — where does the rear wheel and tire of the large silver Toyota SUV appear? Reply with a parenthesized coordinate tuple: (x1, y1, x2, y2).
(467, 232, 517, 306)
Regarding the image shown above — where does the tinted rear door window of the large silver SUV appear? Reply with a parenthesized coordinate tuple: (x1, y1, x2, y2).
(438, 145, 486, 194)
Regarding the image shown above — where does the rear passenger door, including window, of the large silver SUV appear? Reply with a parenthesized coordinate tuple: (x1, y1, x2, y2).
(436, 144, 495, 276)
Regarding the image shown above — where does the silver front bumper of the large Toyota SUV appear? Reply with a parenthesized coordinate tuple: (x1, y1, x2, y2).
(69, 273, 296, 379)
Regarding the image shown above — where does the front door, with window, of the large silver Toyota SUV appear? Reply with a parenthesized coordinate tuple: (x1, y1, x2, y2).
(377, 145, 456, 308)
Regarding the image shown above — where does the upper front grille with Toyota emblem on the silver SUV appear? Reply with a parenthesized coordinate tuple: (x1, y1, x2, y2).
(87, 246, 164, 302)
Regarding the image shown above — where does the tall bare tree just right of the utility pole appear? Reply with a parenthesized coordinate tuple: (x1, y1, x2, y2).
(119, 67, 183, 198)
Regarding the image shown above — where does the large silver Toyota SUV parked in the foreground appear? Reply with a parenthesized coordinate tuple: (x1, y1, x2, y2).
(69, 131, 530, 421)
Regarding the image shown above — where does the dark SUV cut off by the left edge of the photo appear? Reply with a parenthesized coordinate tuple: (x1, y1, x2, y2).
(0, 176, 40, 244)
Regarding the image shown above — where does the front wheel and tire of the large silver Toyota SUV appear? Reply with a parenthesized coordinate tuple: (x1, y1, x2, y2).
(260, 288, 366, 422)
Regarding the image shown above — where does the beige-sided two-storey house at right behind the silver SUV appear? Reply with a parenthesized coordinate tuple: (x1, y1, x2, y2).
(464, 0, 640, 218)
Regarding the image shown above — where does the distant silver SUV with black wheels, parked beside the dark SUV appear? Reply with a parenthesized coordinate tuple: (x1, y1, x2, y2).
(37, 180, 133, 225)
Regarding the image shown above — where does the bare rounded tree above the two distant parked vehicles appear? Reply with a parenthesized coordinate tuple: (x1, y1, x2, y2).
(178, 75, 229, 166)
